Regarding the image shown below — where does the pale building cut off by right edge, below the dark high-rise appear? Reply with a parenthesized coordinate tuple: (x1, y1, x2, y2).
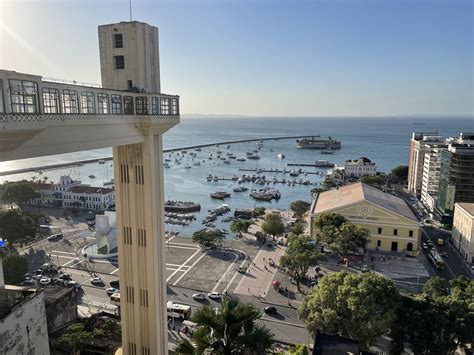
(452, 203, 474, 264)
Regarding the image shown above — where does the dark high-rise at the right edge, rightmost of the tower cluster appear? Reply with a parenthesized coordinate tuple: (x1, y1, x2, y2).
(434, 136, 474, 224)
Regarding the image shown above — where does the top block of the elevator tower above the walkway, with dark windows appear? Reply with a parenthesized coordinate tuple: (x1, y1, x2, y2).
(99, 21, 160, 93)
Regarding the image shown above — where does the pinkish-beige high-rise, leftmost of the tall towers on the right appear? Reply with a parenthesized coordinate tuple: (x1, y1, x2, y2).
(408, 132, 443, 197)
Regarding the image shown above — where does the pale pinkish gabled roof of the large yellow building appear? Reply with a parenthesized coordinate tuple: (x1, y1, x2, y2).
(312, 182, 419, 222)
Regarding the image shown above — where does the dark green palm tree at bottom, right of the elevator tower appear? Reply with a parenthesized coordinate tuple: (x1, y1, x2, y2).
(175, 298, 273, 355)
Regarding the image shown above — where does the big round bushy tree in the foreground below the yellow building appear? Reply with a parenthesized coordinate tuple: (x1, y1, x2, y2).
(299, 272, 399, 348)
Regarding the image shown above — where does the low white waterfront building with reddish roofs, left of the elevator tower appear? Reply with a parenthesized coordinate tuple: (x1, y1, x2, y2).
(31, 176, 115, 210)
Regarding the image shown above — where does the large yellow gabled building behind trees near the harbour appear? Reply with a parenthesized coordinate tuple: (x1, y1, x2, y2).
(310, 182, 421, 255)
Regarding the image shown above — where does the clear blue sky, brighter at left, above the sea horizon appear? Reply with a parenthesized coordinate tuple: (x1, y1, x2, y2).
(0, 0, 474, 117)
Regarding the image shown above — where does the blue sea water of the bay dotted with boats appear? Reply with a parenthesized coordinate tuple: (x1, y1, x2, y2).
(0, 116, 474, 235)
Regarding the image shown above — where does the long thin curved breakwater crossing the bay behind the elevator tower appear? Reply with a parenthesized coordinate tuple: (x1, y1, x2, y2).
(0, 134, 317, 176)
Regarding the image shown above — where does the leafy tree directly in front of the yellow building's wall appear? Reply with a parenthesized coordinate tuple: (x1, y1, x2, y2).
(322, 222, 370, 260)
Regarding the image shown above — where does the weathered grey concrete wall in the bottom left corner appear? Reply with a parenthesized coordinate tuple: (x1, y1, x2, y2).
(0, 292, 49, 355)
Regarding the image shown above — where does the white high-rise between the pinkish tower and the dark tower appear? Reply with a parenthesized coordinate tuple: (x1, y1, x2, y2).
(421, 144, 446, 212)
